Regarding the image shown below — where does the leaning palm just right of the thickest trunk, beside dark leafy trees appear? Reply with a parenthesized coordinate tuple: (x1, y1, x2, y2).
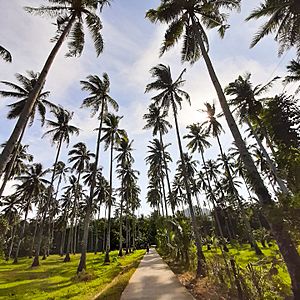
(224, 73, 288, 194)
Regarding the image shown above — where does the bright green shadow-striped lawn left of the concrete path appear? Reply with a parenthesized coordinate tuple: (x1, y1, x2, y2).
(0, 250, 145, 300)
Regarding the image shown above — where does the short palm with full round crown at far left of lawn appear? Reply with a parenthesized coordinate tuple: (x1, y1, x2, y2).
(14, 163, 49, 263)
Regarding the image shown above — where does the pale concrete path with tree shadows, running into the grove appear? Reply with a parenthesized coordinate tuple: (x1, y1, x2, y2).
(121, 249, 194, 300)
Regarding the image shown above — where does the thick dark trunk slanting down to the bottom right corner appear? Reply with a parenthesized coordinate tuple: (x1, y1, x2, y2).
(198, 24, 300, 299)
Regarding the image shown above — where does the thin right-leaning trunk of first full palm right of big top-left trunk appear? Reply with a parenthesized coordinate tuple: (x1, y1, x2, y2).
(31, 136, 63, 267)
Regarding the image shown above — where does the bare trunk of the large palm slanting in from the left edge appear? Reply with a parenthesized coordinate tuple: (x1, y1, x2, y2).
(0, 14, 76, 176)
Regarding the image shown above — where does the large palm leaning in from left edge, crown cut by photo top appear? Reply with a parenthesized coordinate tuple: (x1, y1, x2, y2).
(0, 0, 110, 175)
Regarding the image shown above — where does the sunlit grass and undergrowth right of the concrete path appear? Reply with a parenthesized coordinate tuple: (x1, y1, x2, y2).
(160, 245, 291, 300)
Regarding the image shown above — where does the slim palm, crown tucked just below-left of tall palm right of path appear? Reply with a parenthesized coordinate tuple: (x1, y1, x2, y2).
(143, 103, 173, 213)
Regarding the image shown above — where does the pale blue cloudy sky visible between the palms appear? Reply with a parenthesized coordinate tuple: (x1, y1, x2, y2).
(0, 0, 294, 214)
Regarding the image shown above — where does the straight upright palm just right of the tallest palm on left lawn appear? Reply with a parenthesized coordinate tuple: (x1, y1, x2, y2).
(102, 113, 127, 262)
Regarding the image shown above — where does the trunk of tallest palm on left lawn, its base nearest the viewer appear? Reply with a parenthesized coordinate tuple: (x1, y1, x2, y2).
(77, 103, 105, 274)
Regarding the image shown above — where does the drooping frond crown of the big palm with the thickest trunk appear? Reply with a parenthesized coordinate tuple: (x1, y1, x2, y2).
(146, 0, 240, 63)
